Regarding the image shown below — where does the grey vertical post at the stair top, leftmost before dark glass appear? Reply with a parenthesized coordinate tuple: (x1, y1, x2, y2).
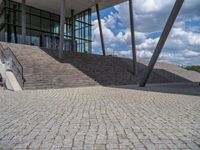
(22, 0, 26, 44)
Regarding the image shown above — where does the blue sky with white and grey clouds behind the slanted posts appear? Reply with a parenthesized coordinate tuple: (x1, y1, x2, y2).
(92, 0, 200, 66)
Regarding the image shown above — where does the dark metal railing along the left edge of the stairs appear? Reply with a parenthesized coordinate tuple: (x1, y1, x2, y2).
(0, 44, 25, 88)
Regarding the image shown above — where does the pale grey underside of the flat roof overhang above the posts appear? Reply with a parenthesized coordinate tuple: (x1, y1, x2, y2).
(14, 0, 127, 17)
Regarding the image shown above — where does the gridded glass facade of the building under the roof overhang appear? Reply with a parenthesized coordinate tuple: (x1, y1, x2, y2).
(0, 0, 92, 53)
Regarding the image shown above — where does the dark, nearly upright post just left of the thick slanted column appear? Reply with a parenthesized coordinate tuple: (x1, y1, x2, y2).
(129, 0, 137, 75)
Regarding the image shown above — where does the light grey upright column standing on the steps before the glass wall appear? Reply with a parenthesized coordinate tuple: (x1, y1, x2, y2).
(59, 0, 65, 59)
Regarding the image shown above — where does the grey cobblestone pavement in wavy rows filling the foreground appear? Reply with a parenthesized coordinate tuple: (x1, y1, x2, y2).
(0, 87, 200, 150)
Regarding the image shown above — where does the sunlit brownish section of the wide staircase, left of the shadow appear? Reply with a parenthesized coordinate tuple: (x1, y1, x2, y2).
(3, 43, 97, 89)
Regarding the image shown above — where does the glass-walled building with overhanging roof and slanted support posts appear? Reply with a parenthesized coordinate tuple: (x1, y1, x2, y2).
(0, 0, 184, 87)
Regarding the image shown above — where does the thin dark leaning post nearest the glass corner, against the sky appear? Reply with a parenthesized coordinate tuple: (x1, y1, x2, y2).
(96, 4, 106, 56)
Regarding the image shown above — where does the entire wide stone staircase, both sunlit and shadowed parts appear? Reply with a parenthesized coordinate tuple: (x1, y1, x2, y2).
(1, 42, 200, 89)
